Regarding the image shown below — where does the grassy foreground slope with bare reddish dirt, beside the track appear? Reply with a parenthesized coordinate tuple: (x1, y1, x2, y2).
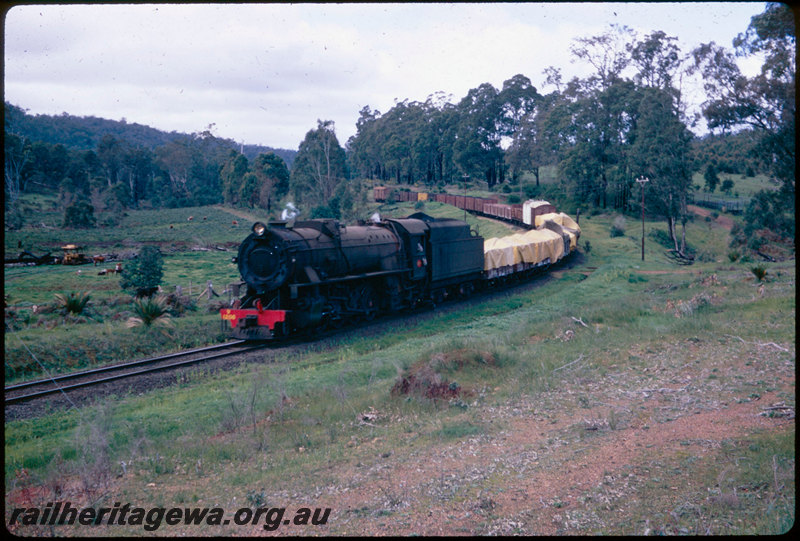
(5, 188, 795, 535)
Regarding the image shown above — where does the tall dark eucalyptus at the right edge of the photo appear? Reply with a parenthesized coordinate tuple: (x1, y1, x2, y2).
(693, 3, 797, 243)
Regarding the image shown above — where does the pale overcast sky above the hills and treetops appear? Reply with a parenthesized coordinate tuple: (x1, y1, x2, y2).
(4, 2, 765, 149)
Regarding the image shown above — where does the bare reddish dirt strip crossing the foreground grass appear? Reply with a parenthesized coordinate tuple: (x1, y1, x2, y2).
(241, 339, 794, 535)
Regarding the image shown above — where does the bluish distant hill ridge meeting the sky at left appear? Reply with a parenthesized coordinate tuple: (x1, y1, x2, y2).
(4, 102, 297, 169)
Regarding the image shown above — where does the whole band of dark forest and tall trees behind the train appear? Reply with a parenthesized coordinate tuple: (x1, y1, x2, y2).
(4, 3, 795, 260)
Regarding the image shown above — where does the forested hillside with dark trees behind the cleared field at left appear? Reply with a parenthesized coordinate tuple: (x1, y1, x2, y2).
(4, 103, 296, 216)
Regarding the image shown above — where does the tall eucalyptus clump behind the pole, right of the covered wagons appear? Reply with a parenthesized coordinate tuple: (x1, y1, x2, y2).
(552, 21, 692, 236)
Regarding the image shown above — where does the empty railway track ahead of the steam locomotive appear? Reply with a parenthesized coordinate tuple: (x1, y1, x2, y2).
(5, 340, 267, 404)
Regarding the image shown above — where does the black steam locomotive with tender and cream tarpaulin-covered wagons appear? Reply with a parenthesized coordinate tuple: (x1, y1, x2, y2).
(220, 186, 580, 340)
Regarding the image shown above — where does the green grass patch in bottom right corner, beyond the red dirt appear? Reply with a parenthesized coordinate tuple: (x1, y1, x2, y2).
(584, 432, 795, 535)
